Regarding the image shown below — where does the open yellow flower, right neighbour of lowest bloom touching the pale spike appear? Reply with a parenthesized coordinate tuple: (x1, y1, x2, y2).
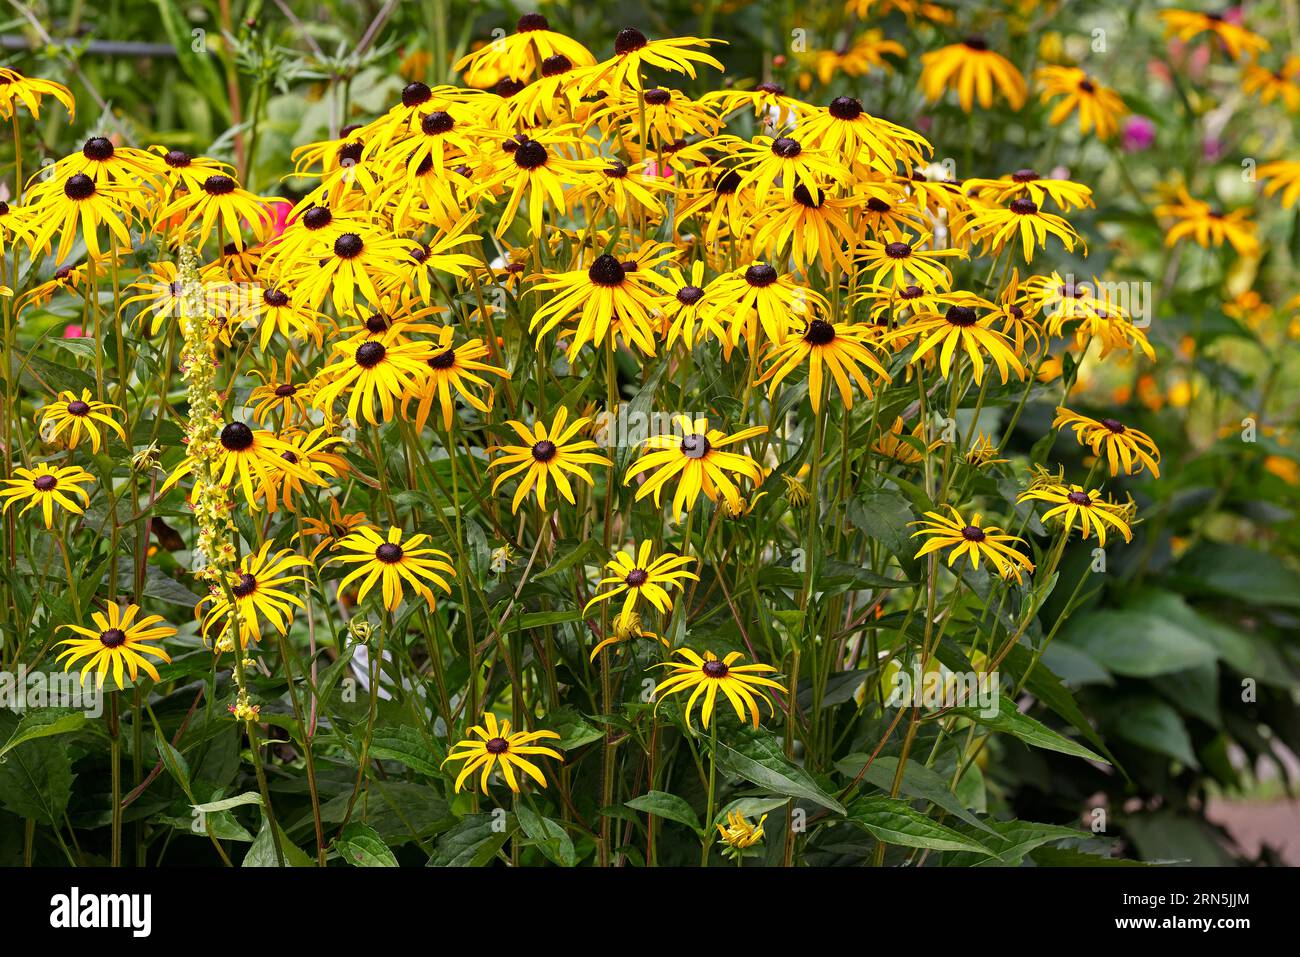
(325, 525, 456, 611)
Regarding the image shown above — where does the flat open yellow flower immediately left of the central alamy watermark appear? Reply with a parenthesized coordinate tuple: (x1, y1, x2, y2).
(488, 406, 614, 512)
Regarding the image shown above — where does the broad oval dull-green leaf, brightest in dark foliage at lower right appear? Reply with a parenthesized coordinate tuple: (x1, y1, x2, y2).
(1061, 609, 1217, 677)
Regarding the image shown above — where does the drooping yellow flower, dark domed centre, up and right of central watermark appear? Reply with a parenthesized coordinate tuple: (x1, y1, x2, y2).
(758, 319, 889, 415)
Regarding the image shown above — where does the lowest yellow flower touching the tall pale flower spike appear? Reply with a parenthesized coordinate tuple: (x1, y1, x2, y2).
(194, 542, 311, 648)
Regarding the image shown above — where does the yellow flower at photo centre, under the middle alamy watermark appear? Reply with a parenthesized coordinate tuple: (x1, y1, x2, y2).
(623, 415, 767, 518)
